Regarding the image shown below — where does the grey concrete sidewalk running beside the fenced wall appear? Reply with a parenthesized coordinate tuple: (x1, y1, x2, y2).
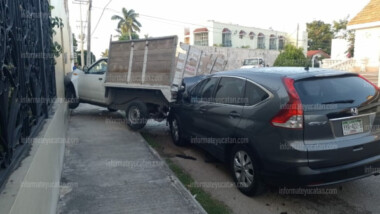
(57, 104, 205, 214)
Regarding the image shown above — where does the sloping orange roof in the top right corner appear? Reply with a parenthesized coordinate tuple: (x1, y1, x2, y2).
(348, 0, 380, 25)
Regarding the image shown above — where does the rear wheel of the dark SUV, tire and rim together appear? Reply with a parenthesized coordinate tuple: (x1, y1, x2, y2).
(230, 146, 265, 196)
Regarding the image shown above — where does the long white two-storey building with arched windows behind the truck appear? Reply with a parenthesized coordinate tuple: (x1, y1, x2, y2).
(184, 21, 307, 55)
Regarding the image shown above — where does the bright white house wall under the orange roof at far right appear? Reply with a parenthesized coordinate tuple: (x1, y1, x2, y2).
(354, 26, 380, 67)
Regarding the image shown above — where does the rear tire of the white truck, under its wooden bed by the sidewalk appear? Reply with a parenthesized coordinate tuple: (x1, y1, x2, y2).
(125, 101, 148, 130)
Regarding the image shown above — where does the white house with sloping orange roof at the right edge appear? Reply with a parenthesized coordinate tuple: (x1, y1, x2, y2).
(347, 0, 380, 71)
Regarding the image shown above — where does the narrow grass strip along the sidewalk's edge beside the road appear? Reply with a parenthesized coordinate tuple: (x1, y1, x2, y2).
(141, 133, 232, 214)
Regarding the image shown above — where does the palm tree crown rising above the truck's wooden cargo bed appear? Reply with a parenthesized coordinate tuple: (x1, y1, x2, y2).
(111, 7, 141, 40)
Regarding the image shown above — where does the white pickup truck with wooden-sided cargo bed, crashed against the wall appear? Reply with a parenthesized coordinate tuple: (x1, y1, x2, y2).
(65, 36, 232, 129)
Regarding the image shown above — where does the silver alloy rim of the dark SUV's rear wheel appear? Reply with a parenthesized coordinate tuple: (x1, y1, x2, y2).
(234, 151, 255, 188)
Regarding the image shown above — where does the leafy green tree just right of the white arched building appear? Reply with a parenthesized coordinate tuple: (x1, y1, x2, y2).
(306, 21, 334, 54)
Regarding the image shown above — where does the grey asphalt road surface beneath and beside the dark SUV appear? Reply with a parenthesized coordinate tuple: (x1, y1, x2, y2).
(141, 121, 380, 214)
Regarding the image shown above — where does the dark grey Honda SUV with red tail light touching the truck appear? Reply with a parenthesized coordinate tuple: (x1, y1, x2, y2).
(168, 68, 380, 195)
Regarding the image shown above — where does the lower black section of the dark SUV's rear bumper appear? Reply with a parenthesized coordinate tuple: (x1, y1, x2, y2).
(261, 155, 380, 187)
